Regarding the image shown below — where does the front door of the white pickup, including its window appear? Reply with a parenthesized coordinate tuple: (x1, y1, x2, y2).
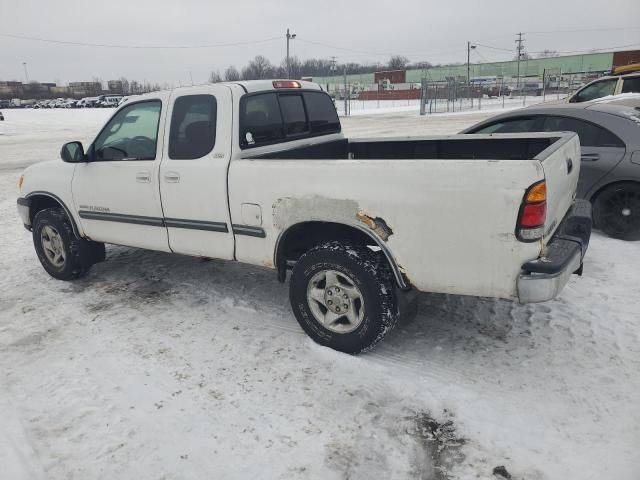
(72, 93, 169, 251)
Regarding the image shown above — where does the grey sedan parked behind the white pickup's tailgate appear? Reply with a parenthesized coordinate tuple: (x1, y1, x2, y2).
(462, 95, 640, 240)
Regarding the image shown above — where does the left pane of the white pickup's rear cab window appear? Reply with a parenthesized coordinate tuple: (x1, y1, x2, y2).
(240, 93, 284, 147)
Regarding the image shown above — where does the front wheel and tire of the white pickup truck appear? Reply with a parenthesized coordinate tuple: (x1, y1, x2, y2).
(33, 208, 105, 280)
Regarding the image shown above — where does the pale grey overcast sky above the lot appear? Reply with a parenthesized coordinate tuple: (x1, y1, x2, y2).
(0, 0, 640, 85)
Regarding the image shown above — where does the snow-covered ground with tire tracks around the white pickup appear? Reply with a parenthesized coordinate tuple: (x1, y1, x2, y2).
(0, 110, 640, 480)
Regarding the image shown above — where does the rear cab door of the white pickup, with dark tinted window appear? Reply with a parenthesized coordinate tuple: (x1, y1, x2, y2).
(160, 85, 234, 259)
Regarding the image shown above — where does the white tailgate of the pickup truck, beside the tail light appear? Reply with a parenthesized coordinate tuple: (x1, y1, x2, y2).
(536, 132, 580, 245)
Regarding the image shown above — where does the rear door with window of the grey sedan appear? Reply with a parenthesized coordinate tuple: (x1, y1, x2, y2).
(542, 115, 625, 197)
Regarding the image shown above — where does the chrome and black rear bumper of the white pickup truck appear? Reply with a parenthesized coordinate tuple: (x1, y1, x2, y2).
(518, 200, 591, 303)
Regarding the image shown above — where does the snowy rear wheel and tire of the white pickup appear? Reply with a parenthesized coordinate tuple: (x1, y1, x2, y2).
(289, 242, 400, 354)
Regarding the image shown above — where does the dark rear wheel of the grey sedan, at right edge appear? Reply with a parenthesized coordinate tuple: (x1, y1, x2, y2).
(593, 182, 640, 240)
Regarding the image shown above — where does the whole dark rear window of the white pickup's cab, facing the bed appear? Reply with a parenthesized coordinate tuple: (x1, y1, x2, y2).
(240, 90, 340, 149)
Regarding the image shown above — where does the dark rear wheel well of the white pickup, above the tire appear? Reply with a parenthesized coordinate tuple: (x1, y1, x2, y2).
(274, 222, 407, 289)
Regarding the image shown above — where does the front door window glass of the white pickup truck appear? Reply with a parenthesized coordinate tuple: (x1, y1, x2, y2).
(94, 100, 162, 160)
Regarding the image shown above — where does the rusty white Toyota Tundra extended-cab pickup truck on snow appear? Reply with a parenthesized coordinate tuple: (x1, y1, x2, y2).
(18, 80, 591, 353)
